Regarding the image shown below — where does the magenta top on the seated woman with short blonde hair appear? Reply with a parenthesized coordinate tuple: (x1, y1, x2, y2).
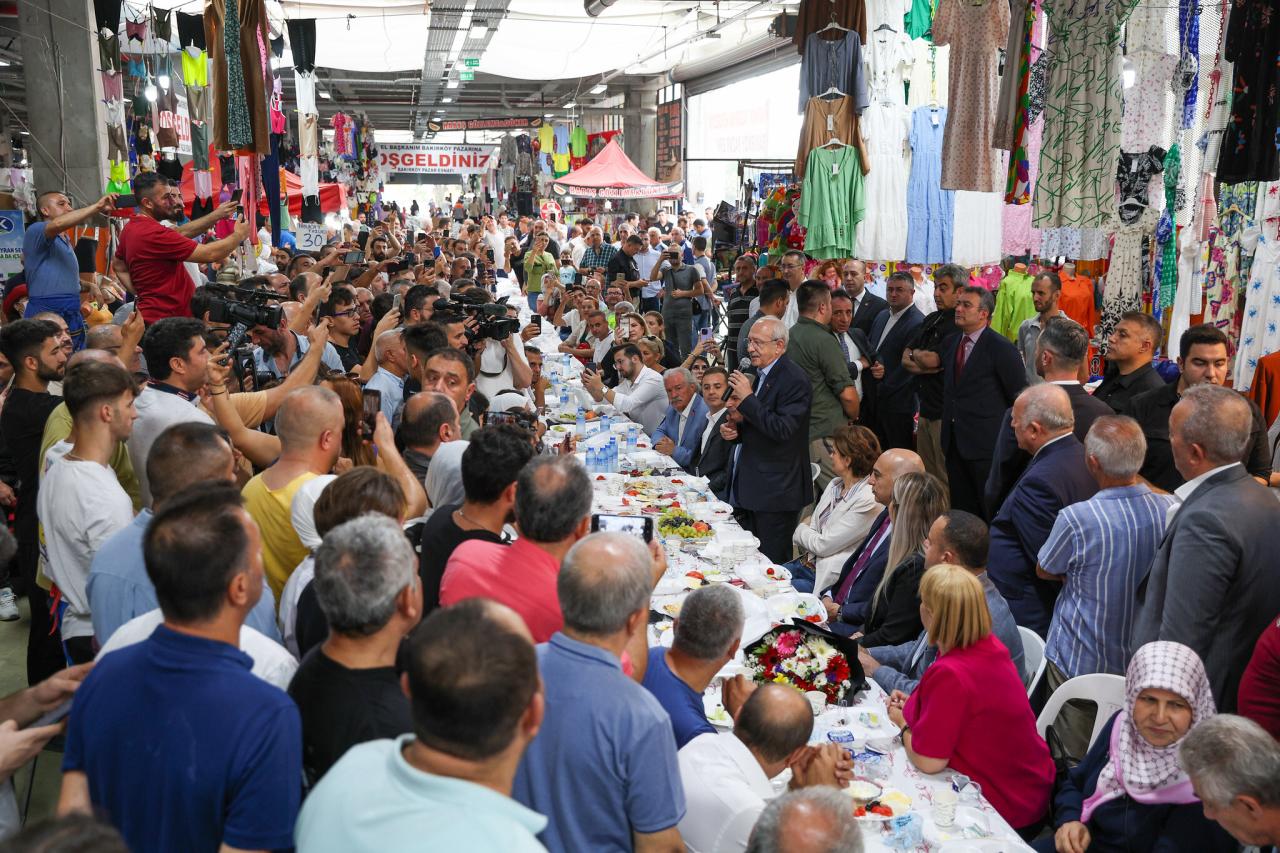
(902, 634, 1053, 829)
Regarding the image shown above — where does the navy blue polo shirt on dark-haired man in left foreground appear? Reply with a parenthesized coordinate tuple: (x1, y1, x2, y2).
(63, 625, 302, 853)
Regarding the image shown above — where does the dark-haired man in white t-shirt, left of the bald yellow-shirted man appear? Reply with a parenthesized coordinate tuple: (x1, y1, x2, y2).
(129, 316, 214, 506)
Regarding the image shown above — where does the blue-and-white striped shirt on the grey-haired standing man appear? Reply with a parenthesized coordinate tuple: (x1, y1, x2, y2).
(1039, 485, 1174, 678)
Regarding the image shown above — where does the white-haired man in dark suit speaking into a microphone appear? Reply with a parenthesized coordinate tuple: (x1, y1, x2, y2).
(721, 316, 813, 562)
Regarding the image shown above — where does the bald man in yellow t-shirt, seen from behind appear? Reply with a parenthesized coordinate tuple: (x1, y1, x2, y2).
(243, 386, 344, 601)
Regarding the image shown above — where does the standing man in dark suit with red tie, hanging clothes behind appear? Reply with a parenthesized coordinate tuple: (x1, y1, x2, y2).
(940, 287, 1027, 520)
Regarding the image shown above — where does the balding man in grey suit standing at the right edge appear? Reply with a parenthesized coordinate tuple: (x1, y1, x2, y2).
(1133, 383, 1280, 711)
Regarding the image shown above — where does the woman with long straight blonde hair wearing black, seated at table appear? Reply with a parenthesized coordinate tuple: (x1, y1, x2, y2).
(855, 473, 948, 648)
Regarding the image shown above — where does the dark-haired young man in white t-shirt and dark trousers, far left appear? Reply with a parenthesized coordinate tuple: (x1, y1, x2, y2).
(37, 361, 137, 663)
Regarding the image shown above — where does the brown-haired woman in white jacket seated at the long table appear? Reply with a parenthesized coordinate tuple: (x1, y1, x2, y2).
(787, 424, 884, 592)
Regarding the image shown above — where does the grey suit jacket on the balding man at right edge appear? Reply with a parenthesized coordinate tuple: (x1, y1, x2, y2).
(1133, 465, 1280, 712)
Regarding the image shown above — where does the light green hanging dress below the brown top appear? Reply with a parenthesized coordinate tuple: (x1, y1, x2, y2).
(796, 145, 867, 259)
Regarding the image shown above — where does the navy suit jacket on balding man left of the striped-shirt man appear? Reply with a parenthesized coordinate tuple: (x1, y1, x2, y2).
(987, 435, 1095, 635)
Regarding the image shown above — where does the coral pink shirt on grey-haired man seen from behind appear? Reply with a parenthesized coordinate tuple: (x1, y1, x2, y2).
(440, 539, 564, 643)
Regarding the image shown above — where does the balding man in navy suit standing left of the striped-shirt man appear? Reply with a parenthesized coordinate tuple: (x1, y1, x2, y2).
(987, 383, 1098, 637)
